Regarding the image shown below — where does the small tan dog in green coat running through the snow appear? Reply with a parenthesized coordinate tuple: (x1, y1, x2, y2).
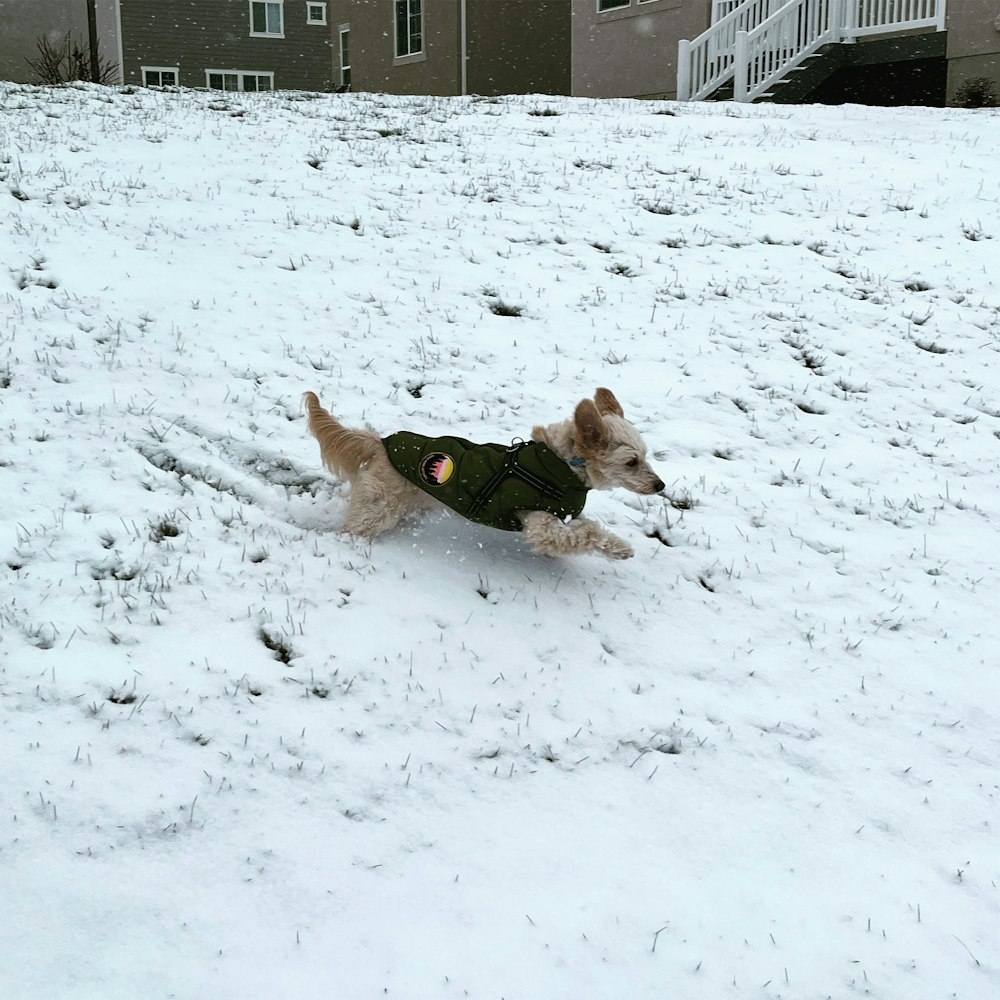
(303, 389, 663, 559)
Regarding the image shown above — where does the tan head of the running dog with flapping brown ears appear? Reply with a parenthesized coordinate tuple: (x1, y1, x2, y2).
(573, 389, 663, 495)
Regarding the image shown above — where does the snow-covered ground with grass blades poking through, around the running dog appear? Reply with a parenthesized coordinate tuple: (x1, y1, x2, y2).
(0, 85, 1000, 1000)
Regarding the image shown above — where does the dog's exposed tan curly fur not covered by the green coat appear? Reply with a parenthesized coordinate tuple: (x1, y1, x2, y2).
(303, 389, 663, 559)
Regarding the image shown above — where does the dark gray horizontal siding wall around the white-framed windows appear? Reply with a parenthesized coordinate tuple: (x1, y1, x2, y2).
(121, 0, 334, 91)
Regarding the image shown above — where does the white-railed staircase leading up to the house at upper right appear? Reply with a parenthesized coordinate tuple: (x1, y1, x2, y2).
(677, 0, 947, 102)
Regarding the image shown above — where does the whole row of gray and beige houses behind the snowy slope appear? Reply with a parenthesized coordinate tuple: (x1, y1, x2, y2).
(0, 0, 1000, 105)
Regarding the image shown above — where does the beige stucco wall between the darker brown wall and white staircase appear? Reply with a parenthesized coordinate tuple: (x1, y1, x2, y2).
(572, 0, 711, 98)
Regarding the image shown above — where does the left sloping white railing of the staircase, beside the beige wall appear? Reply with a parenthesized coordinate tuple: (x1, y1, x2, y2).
(677, 0, 791, 101)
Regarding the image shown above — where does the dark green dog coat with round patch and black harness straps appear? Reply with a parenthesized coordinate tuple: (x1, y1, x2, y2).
(382, 431, 589, 531)
